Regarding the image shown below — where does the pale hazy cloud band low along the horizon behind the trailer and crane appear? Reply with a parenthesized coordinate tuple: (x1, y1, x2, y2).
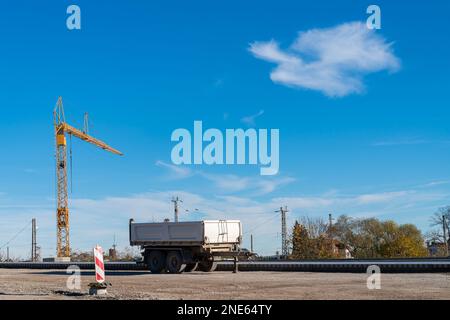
(0, 189, 450, 257)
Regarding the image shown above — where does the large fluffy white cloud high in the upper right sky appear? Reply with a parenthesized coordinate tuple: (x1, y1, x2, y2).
(249, 22, 400, 97)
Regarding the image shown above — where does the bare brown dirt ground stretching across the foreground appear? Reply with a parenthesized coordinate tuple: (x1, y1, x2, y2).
(0, 269, 450, 300)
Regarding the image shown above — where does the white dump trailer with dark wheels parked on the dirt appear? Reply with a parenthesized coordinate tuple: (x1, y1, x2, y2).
(130, 219, 250, 273)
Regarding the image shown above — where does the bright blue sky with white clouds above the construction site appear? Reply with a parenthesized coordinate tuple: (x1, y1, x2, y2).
(0, 0, 450, 256)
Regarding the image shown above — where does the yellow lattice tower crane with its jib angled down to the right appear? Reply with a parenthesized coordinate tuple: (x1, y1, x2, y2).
(53, 97, 123, 259)
